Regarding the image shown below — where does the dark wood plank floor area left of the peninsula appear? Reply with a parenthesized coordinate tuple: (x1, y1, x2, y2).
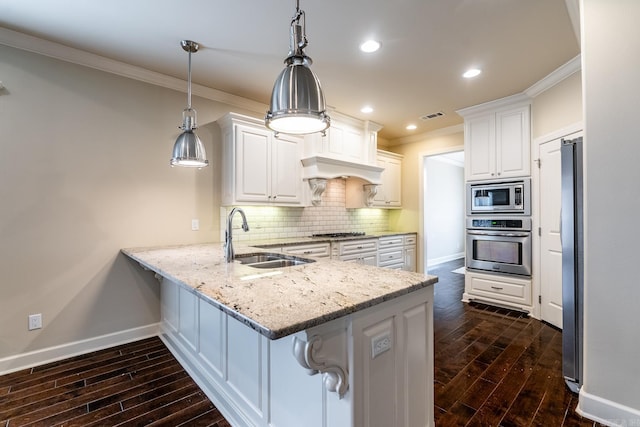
(0, 337, 230, 427)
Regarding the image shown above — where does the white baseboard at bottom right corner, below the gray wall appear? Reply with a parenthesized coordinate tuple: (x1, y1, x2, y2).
(576, 387, 640, 427)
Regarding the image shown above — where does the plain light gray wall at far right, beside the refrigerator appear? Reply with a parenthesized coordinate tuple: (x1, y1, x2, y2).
(581, 0, 640, 416)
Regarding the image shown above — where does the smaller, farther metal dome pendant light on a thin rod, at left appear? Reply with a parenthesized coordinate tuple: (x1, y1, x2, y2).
(171, 40, 209, 168)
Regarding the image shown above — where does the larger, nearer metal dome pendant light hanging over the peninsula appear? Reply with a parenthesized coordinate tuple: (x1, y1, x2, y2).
(265, 0, 331, 135)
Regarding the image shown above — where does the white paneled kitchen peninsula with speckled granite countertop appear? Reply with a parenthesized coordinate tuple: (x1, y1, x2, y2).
(122, 244, 437, 427)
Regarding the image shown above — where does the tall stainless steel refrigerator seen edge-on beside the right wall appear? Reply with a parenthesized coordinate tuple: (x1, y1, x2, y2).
(560, 137, 584, 393)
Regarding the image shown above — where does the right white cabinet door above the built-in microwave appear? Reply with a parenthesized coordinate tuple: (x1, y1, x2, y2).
(496, 105, 531, 178)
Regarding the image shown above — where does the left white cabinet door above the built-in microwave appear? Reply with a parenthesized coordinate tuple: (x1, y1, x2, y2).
(464, 114, 496, 181)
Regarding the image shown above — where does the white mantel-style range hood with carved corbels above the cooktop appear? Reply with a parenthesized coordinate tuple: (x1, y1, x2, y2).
(302, 156, 384, 206)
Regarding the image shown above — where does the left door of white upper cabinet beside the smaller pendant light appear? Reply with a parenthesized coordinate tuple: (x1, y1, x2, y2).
(235, 125, 271, 202)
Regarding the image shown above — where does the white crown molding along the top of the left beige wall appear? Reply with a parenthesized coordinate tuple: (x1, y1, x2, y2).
(0, 27, 267, 114)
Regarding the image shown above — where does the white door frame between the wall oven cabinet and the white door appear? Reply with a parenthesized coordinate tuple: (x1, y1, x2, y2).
(531, 121, 584, 319)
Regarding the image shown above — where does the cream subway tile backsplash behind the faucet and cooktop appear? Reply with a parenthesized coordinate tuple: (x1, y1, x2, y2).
(220, 179, 389, 241)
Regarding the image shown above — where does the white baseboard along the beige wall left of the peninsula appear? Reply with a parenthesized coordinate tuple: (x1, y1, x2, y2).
(0, 323, 160, 375)
